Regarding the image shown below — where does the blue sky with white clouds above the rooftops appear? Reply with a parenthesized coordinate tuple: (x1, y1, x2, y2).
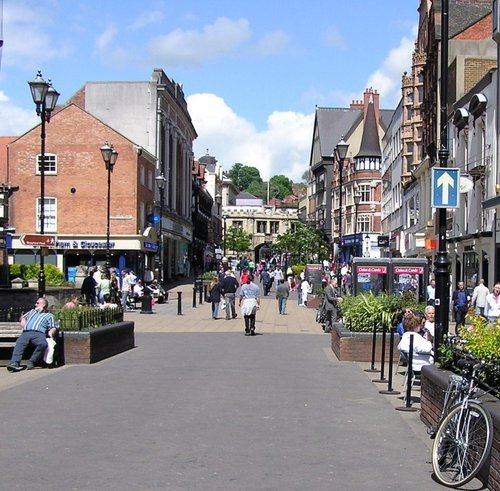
(0, 0, 419, 182)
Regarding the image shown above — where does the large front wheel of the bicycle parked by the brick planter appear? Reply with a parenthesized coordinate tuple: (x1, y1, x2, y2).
(432, 402, 493, 487)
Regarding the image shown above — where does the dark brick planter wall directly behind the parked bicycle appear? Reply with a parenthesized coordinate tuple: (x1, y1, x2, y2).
(420, 365, 500, 490)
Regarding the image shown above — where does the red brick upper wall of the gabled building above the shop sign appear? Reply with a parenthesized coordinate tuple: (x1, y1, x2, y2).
(9, 105, 154, 235)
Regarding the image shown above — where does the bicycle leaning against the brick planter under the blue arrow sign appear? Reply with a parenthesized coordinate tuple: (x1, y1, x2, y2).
(430, 355, 493, 488)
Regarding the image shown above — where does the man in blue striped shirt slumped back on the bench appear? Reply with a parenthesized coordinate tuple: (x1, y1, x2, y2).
(7, 298, 56, 372)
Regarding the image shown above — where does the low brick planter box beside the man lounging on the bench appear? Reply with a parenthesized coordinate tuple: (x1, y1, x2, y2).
(59, 322, 135, 364)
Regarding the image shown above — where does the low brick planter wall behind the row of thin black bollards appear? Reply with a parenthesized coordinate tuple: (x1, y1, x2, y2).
(331, 323, 399, 363)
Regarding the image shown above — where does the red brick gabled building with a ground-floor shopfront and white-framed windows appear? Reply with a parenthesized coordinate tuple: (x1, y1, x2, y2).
(6, 104, 157, 280)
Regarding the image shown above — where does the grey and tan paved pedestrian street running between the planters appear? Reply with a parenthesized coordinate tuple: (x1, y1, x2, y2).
(0, 285, 458, 491)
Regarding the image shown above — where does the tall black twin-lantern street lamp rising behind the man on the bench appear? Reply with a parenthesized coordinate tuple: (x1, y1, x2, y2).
(28, 70, 59, 297)
